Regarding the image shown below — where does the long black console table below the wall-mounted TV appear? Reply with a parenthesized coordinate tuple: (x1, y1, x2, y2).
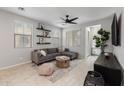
(94, 53, 122, 86)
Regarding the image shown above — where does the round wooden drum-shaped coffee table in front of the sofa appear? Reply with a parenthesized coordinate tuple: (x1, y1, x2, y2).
(56, 56, 70, 68)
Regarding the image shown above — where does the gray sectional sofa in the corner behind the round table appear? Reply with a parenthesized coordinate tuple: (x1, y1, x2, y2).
(31, 48, 78, 65)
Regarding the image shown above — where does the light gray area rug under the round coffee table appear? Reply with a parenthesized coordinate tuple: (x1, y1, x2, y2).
(45, 60, 80, 83)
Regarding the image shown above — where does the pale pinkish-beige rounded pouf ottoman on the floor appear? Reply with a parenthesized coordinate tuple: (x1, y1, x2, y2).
(38, 63, 55, 76)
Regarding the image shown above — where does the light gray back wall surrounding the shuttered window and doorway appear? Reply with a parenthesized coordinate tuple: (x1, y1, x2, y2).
(63, 16, 113, 58)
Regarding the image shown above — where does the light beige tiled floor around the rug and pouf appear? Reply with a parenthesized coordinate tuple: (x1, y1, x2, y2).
(0, 56, 97, 86)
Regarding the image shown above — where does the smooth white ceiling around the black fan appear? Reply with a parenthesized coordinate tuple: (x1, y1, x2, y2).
(0, 7, 118, 28)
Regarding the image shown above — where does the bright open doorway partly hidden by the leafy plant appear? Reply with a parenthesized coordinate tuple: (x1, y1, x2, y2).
(85, 25, 101, 58)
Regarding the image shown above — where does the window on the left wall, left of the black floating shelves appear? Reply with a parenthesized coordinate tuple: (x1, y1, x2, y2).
(14, 21, 33, 48)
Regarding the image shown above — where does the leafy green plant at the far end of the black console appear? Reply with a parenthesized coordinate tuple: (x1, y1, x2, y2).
(93, 28, 110, 53)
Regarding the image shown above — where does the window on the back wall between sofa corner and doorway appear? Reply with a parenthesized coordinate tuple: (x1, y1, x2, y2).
(66, 31, 80, 47)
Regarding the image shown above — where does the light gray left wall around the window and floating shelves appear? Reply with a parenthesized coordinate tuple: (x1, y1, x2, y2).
(0, 10, 61, 68)
